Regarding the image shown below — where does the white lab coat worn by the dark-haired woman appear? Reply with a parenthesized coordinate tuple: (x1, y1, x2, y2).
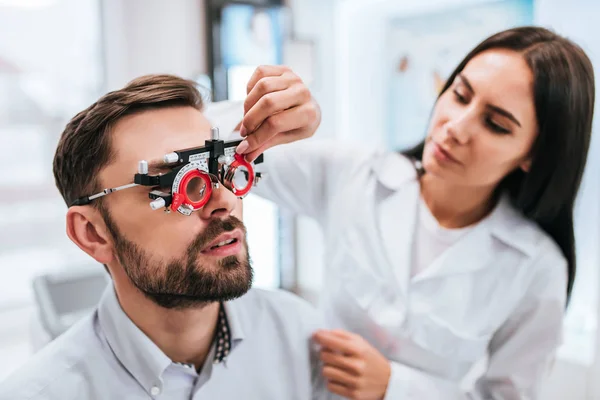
(254, 139, 567, 400)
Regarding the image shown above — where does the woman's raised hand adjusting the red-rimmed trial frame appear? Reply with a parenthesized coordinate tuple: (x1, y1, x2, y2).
(236, 66, 321, 161)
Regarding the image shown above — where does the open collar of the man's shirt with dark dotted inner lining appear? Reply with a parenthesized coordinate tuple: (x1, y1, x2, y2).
(98, 284, 239, 393)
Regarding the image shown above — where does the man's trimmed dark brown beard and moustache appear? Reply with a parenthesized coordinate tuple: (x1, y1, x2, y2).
(101, 206, 253, 309)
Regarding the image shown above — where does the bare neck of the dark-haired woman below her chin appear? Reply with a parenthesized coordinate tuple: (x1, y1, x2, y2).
(420, 173, 497, 228)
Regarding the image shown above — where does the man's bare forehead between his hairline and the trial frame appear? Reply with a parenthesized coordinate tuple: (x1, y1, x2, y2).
(106, 107, 211, 178)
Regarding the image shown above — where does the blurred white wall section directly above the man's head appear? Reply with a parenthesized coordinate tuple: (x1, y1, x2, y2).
(102, 0, 207, 90)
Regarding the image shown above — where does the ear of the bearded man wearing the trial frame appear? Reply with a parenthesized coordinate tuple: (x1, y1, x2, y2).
(67, 206, 114, 264)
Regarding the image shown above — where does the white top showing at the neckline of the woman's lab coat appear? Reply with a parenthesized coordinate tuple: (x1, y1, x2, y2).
(411, 196, 483, 278)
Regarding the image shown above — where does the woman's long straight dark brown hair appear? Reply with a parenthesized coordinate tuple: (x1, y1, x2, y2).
(403, 27, 595, 301)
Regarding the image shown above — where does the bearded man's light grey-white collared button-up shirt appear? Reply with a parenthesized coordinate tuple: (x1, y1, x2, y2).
(0, 285, 325, 400)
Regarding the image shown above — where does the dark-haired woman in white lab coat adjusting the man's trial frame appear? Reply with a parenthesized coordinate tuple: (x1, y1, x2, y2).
(232, 27, 594, 399)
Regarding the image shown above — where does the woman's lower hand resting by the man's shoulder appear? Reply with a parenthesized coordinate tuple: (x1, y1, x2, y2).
(313, 330, 391, 400)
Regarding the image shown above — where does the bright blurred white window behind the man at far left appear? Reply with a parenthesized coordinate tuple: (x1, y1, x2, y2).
(0, 0, 103, 308)
